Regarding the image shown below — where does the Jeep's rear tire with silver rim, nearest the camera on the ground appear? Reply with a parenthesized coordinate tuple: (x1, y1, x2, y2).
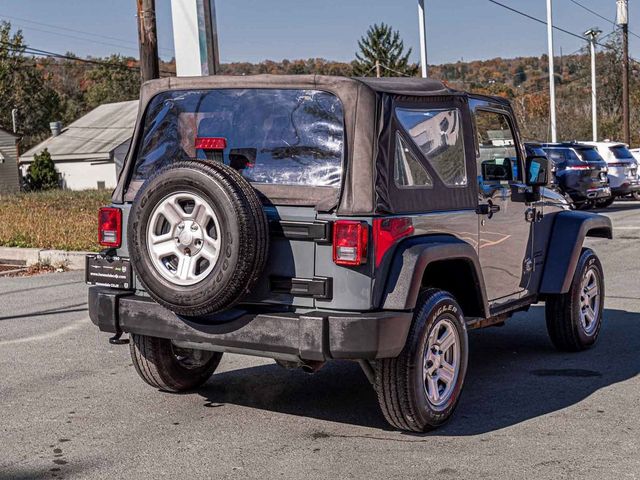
(375, 289, 468, 432)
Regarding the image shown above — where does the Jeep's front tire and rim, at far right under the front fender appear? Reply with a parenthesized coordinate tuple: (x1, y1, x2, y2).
(545, 248, 605, 352)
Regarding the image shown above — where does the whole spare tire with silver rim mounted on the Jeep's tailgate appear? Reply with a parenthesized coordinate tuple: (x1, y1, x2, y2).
(127, 161, 269, 317)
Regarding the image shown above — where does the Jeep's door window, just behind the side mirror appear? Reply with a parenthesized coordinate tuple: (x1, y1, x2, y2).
(475, 110, 519, 184)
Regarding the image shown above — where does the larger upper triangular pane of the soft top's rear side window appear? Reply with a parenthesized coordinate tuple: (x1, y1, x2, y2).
(396, 108, 468, 187)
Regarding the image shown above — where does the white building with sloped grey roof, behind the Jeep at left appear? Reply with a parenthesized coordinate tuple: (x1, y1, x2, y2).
(20, 100, 138, 190)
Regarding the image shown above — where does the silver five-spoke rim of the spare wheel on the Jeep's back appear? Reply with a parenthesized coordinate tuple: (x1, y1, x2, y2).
(147, 192, 221, 286)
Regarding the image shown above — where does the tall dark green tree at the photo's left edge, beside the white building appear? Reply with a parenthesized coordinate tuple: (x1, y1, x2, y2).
(0, 22, 60, 149)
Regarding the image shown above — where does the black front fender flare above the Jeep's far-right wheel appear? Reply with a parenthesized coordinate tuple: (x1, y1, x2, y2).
(539, 211, 613, 295)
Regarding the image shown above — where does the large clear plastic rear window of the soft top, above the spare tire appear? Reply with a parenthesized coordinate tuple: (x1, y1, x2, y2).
(132, 89, 344, 186)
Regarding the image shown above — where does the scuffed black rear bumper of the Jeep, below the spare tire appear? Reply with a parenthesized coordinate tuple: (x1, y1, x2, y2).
(89, 287, 412, 361)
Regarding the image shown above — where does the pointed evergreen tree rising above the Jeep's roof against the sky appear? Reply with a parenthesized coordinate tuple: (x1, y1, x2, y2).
(353, 23, 418, 77)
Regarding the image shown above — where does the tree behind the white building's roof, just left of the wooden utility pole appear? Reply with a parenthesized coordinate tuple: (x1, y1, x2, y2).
(85, 55, 140, 108)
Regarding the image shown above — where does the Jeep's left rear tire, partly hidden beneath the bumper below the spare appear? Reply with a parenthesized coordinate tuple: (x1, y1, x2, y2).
(129, 334, 222, 393)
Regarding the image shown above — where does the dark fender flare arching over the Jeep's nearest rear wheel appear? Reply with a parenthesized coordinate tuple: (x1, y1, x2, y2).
(382, 235, 489, 318)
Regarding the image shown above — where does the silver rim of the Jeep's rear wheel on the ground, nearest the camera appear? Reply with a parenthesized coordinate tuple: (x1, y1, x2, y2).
(422, 318, 460, 408)
